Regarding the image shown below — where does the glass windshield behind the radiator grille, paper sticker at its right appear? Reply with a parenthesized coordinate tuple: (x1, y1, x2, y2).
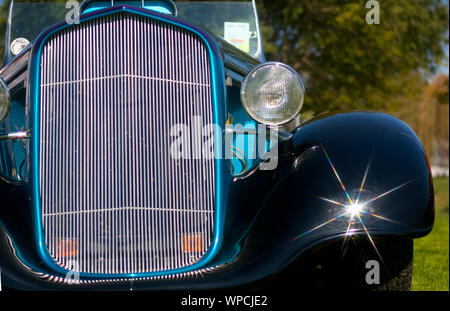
(7, 2, 262, 59)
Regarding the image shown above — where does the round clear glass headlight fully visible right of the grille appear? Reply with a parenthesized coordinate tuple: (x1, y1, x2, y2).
(241, 63, 305, 125)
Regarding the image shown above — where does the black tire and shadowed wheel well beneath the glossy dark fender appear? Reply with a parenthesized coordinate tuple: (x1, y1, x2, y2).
(270, 237, 413, 291)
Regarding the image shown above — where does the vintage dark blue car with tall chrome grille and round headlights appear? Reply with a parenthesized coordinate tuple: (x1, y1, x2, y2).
(0, 0, 434, 290)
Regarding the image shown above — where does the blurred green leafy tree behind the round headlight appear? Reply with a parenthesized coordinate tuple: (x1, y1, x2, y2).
(259, 0, 449, 113)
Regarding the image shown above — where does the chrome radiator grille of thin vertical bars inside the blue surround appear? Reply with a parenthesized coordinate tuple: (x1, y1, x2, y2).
(38, 13, 215, 274)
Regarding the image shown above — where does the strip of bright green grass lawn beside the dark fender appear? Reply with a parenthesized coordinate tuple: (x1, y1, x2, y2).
(411, 178, 449, 291)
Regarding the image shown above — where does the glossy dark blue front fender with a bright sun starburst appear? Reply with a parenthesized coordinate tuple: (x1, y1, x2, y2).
(227, 112, 434, 280)
